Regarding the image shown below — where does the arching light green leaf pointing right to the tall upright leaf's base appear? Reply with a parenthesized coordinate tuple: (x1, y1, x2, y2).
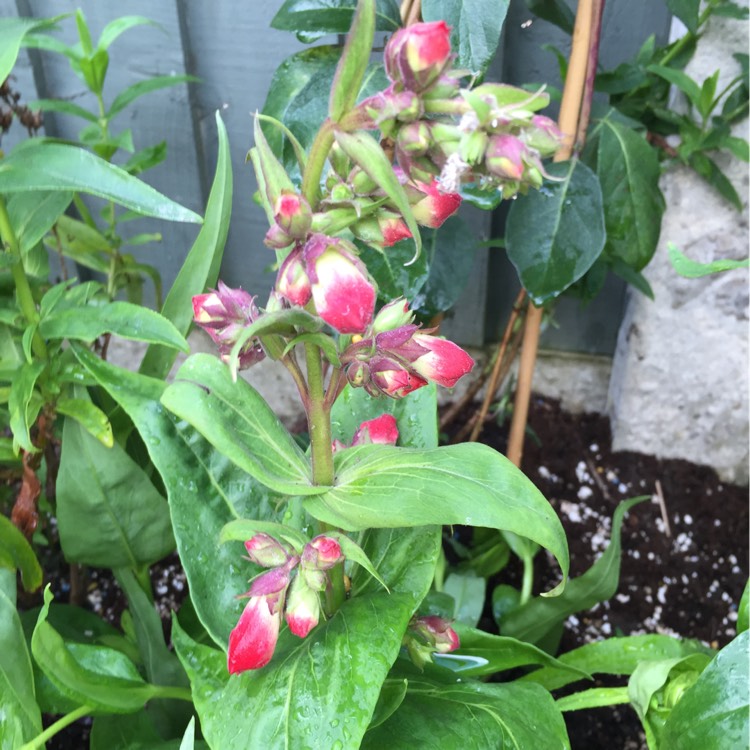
(39, 302, 189, 352)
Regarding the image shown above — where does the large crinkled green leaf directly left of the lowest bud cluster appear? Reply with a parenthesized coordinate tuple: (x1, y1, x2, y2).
(71, 349, 290, 648)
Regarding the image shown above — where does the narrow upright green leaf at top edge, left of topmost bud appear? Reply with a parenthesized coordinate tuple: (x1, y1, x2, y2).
(328, 0, 375, 122)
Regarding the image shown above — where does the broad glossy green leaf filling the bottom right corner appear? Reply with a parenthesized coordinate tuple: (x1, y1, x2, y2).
(662, 631, 750, 750)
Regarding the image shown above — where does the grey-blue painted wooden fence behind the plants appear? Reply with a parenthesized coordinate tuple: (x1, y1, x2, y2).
(0, 0, 669, 353)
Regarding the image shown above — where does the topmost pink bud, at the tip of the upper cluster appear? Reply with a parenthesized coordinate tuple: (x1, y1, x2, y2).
(384, 21, 451, 93)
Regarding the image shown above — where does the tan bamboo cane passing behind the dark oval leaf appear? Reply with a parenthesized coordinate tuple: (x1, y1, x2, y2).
(507, 0, 604, 466)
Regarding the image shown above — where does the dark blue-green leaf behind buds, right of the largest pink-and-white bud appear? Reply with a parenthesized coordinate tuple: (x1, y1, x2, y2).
(407, 216, 479, 317)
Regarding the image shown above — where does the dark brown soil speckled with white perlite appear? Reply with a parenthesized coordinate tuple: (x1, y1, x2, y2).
(33, 397, 749, 750)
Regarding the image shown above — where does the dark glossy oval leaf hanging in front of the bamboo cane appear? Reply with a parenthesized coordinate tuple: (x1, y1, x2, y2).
(505, 161, 606, 304)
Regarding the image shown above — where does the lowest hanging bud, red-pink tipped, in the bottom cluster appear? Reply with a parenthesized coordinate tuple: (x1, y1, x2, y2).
(227, 596, 283, 674)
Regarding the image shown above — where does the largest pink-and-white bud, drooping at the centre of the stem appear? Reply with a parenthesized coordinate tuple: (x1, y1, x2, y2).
(303, 234, 376, 333)
